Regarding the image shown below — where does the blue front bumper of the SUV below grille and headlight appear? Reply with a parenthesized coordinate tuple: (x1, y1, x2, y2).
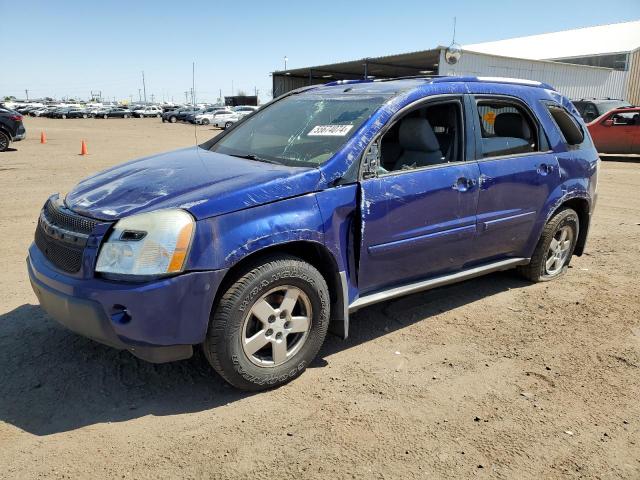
(27, 244, 226, 363)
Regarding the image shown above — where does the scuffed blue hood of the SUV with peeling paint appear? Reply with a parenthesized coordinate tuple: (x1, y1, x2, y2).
(65, 146, 321, 220)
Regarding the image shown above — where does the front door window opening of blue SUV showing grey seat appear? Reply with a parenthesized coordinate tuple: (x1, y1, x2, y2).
(379, 102, 463, 174)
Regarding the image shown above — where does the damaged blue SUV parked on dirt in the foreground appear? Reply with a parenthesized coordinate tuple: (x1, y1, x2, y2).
(27, 77, 599, 390)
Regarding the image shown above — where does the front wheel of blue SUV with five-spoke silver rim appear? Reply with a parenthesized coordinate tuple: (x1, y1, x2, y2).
(203, 256, 330, 391)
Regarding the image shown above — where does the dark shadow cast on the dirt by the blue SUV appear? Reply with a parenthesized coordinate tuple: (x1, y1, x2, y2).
(0, 273, 528, 435)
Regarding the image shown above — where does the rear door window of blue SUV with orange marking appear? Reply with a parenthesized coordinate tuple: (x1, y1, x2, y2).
(477, 99, 540, 158)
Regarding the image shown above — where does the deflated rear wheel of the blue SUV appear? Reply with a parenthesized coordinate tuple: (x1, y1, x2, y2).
(518, 208, 580, 282)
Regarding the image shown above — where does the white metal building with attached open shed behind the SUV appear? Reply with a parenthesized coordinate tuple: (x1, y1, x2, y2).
(272, 21, 640, 104)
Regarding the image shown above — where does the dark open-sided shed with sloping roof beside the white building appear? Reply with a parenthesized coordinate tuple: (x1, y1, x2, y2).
(273, 47, 444, 81)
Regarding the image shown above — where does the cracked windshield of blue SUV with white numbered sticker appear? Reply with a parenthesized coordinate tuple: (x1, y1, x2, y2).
(211, 94, 389, 166)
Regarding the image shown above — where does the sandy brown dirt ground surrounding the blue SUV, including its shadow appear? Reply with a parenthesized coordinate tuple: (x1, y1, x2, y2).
(0, 118, 640, 479)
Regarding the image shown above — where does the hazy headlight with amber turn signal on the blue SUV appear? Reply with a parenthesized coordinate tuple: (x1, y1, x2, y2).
(96, 209, 195, 275)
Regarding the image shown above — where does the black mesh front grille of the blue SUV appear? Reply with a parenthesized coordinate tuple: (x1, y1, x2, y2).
(35, 200, 98, 273)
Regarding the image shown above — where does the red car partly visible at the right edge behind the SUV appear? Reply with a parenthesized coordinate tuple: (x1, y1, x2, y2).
(587, 107, 640, 154)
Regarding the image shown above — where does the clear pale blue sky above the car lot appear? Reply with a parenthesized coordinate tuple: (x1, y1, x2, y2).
(0, 0, 640, 101)
